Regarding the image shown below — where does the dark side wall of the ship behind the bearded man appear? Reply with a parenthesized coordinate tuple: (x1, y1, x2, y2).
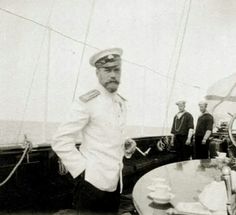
(0, 137, 176, 214)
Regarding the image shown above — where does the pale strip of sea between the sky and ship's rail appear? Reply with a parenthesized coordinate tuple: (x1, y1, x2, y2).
(0, 120, 170, 147)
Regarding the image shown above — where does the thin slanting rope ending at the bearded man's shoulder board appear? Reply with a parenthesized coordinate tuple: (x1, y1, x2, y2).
(72, 0, 95, 100)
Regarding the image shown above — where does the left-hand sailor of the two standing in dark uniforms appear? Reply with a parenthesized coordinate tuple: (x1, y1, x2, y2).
(171, 101, 194, 161)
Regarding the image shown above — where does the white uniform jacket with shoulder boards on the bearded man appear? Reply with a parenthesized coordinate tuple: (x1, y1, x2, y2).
(52, 85, 126, 192)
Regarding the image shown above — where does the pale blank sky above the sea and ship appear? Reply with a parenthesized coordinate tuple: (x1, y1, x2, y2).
(0, 0, 236, 143)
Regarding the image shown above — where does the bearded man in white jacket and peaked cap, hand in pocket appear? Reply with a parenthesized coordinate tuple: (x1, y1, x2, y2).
(52, 48, 136, 214)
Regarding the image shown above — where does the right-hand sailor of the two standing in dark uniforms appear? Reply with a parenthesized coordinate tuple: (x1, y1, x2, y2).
(195, 101, 214, 159)
